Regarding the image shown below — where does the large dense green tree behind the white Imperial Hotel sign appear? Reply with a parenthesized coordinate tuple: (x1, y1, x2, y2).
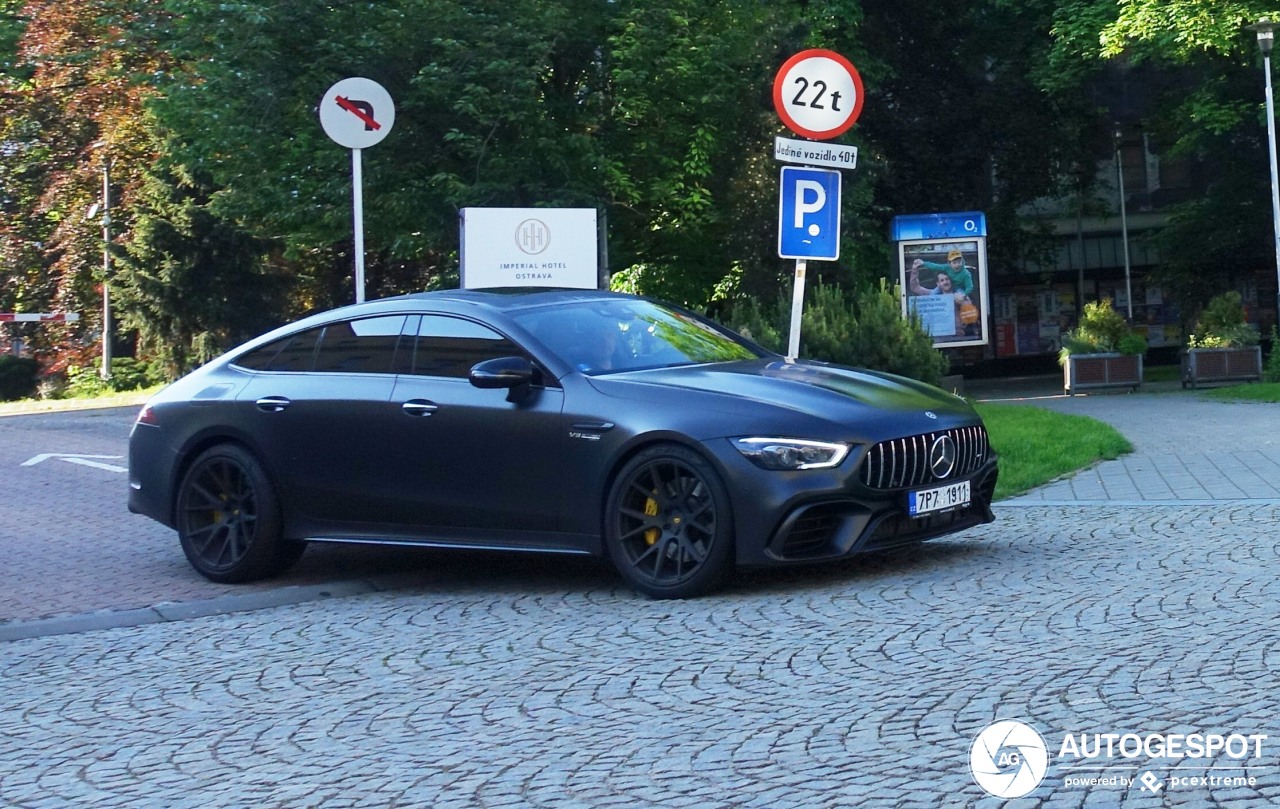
(142, 0, 798, 308)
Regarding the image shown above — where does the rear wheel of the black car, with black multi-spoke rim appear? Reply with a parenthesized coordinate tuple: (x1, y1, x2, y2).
(175, 444, 306, 584)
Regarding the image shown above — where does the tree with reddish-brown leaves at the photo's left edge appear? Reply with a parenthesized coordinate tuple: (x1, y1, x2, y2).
(0, 0, 164, 360)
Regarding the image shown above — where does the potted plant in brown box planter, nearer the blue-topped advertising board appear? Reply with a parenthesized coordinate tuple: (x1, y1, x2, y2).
(1057, 301, 1147, 396)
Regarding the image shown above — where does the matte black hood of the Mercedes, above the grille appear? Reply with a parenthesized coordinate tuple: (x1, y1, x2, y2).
(591, 360, 980, 438)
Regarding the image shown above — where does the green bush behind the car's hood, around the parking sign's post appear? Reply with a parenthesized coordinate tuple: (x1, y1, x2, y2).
(730, 280, 950, 385)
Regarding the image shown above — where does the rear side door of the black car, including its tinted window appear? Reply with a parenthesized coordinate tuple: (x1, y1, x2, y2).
(237, 315, 407, 534)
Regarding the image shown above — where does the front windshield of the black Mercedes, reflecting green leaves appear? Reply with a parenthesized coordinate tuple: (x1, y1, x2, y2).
(512, 298, 762, 375)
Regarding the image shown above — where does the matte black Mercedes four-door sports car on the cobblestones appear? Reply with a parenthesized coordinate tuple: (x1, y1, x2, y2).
(129, 289, 997, 598)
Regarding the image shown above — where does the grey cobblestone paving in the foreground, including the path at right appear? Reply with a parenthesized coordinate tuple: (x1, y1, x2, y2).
(0, 384, 1280, 808)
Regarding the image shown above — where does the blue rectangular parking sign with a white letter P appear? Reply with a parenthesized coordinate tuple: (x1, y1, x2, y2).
(778, 166, 840, 261)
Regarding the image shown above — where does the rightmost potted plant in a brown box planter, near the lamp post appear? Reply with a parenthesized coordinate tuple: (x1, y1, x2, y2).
(1183, 292, 1262, 388)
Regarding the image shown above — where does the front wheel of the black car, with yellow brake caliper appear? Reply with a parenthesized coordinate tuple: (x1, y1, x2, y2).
(604, 444, 733, 599)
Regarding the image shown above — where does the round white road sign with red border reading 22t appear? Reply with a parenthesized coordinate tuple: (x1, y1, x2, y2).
(773, 47, 863, 141)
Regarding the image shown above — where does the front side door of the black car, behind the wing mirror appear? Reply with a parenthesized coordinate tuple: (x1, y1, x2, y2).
(373, 315, 567, 541)
